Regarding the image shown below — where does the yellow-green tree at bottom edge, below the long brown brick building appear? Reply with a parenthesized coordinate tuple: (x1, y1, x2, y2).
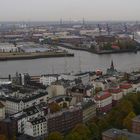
(47, 132, 63, 140)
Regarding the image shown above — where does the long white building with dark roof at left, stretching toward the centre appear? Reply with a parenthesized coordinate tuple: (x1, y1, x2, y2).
(0, 91, 49, 114)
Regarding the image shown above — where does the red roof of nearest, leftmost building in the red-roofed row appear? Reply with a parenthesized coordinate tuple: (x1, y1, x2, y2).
(95, 91, 112, 100)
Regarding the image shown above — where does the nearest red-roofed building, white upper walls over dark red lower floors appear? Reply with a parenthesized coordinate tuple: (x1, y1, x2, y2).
(95, 91, 112, 112)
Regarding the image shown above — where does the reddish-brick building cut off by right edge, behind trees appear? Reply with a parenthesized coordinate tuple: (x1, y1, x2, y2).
(132, 115, 140, 134)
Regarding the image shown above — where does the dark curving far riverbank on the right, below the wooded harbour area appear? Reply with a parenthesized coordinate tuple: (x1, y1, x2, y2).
(59, 43, 139, 55)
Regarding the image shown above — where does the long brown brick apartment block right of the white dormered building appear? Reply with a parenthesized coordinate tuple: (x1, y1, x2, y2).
(47, 107, 83, 133)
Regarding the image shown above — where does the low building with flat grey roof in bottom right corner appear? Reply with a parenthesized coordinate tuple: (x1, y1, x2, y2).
(102, 128, 140, 140)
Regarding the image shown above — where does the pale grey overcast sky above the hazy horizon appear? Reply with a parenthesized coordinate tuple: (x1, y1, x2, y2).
(0, 0, 140, 21)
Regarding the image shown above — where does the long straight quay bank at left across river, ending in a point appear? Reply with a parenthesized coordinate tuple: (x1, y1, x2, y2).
(0, 52, 74, 61)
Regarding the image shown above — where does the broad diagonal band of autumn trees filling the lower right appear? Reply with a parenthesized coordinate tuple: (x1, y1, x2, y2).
(47, 93, 140, 140)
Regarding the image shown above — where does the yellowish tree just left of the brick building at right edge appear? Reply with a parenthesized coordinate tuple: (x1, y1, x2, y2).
(123, 112, 136, 131)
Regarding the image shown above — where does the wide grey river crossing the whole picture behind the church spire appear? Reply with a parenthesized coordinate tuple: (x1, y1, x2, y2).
(0, 47, 140, 77)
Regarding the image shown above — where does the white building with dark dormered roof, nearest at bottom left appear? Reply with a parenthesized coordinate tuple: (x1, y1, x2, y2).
(25, 116, 47, 137)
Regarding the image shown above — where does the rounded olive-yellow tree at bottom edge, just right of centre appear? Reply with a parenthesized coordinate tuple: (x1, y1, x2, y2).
(72, 124, 91, 140)
